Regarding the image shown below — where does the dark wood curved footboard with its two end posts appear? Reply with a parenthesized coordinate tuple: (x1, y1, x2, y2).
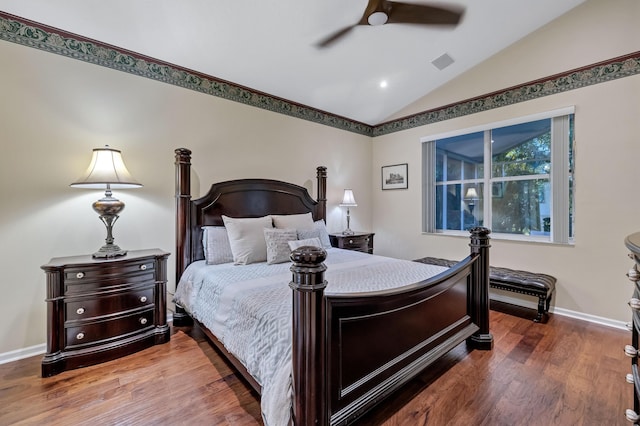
(290, 228, 493, 425)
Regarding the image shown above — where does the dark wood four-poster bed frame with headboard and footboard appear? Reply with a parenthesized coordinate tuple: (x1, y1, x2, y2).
(173, 148, 493, 426)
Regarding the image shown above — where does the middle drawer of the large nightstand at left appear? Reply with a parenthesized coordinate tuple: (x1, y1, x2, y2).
(65, 287, 154, 321)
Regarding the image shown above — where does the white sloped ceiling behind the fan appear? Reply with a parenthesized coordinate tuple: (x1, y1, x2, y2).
(0, 0, 585, 125)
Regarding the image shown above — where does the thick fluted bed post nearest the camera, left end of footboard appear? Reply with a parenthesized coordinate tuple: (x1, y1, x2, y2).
(289, 246, 328, 426)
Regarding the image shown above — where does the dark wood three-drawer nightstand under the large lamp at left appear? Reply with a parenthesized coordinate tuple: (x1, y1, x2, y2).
(42, 249, 169, 377)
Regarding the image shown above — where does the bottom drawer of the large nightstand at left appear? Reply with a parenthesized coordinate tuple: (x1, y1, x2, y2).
(65, 308, 154, 349)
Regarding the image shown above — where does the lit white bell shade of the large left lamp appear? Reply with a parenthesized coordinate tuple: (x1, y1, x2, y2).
(70, 146, 142, 189)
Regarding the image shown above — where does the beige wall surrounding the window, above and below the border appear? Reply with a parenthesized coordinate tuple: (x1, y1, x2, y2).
(372, 0, 640, 321)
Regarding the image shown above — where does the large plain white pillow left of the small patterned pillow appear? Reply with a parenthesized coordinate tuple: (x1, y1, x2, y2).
(222, 216, 272, 265)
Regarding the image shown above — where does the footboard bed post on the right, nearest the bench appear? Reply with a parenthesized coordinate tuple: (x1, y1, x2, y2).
(467, 226, 493, 350)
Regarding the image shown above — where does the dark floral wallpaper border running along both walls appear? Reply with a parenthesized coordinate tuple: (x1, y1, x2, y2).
(0, 11, 640, 137)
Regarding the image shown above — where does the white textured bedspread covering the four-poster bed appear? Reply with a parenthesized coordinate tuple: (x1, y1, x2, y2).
(174, 249, 447, 426)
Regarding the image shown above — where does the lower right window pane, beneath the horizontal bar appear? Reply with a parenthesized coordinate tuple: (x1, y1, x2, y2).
(491, 179, 551, 236)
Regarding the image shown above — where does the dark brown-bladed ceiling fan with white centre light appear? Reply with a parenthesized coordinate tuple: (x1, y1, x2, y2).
(316, 0, 464, 48)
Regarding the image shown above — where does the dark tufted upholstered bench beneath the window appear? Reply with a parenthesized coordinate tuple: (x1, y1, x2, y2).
(415, 257, 556, 322)
